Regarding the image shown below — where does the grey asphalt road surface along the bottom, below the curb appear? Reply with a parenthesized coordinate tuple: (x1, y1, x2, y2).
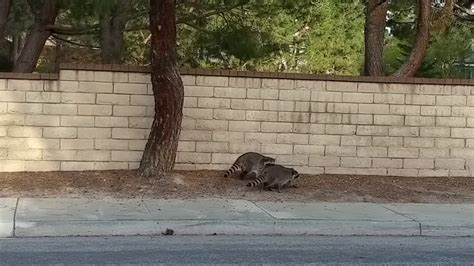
(0, 236, 474, 265)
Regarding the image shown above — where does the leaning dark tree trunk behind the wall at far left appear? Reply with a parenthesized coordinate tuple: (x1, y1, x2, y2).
(13, 0, 59, 73)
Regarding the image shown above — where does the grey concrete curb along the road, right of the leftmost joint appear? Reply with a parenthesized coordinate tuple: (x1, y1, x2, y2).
(14, 220, 474, 237)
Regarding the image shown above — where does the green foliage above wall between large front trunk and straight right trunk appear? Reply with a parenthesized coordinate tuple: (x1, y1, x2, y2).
(179, 0, 364, 74)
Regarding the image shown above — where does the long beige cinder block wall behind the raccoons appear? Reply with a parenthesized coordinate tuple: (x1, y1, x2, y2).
(0, 66, 474, 176)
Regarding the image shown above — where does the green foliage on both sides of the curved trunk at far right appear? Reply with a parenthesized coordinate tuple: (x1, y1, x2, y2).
(384, 0, 474, 78)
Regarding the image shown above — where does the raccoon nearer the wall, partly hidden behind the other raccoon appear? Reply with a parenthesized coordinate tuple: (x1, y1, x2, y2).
(224, 152, 275, 179)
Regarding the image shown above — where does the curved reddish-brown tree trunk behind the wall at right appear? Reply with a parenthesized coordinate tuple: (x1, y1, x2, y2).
(394, 0, 431, 77)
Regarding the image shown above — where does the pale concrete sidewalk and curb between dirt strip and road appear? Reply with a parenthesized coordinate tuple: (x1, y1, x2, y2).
(0, 198, 474, 237)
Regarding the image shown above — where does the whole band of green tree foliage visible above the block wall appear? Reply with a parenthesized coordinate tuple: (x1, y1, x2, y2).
(0, 0, 474, 78)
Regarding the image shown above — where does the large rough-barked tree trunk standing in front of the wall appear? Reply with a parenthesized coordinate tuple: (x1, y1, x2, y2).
(139, 0, 184, 177)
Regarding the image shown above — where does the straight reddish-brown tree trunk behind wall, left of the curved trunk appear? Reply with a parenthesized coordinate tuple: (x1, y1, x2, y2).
(364, 0, 388, 76)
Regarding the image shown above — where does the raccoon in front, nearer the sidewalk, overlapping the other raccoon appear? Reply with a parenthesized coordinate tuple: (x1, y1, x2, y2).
(247, 164, 300, 193)
